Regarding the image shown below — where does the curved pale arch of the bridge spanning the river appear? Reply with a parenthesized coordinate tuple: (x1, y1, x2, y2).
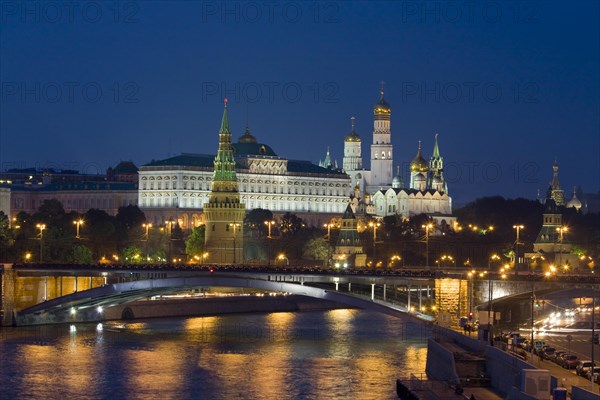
(15, 274, 432, 326)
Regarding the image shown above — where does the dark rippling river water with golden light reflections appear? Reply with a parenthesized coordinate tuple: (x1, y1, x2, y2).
(0, 310, 428, 400)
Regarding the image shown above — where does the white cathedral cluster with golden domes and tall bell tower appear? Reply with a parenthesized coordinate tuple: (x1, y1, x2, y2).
(340, 88, 455, 224)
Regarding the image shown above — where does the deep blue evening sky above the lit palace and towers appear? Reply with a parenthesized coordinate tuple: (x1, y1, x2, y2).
(0, 1, 600, 203)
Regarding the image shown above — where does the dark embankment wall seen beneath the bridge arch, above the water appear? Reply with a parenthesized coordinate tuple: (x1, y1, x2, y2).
(102, 295, 348, 320)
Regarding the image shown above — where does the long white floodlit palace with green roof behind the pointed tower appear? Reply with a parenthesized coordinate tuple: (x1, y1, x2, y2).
(138, 122, 351, 229)
